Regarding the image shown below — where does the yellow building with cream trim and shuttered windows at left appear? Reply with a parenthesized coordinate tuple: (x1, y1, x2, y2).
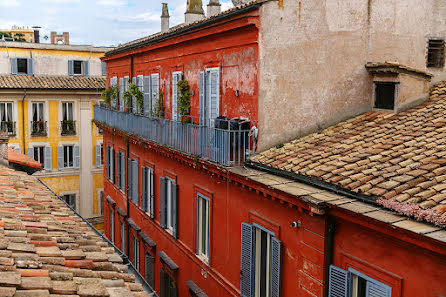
(0, 42, 114, 227)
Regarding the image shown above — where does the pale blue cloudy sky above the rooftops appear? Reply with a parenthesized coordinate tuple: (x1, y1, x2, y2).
(0, 0, 232, 46)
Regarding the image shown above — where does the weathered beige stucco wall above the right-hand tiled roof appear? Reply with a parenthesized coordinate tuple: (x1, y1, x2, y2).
(259, 0, 446, 151)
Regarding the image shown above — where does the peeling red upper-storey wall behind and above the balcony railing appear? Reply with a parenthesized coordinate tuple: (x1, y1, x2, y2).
(104, 12, 259, 122)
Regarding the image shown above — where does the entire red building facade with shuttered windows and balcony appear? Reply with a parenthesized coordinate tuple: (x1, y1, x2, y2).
(95, 5, 446, 297)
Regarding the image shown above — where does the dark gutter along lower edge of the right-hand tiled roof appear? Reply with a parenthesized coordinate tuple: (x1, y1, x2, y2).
(245, 161, 380, 206)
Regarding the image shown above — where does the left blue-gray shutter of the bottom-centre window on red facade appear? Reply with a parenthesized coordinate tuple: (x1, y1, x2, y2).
(240, 223, 254, 297)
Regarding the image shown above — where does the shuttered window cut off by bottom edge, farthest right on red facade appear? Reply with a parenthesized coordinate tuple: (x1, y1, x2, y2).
(328, 265, 392, 297)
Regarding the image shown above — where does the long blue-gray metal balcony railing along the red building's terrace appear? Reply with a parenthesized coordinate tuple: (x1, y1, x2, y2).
(94, 106, 252, 166)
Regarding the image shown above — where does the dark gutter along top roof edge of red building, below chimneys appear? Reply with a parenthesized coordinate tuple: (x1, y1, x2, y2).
(105, 2, 263, 57)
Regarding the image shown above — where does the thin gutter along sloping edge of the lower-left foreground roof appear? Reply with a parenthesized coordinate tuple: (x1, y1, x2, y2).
(37, 179, 158, 297)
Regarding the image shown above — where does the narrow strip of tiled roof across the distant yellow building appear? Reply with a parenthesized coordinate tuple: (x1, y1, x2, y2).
(0, 75, 105, 90)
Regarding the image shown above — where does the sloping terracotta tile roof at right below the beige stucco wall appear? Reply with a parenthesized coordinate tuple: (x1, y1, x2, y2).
(251, 81, 446, 222)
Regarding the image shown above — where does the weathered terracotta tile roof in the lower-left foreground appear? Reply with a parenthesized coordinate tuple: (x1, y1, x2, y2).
(0, 167, 149, 296)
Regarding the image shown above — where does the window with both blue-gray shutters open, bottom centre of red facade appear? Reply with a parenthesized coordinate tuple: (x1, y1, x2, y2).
(240, 223, 281, 297)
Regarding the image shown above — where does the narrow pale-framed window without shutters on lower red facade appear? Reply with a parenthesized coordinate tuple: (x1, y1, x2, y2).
(197, 194, 210, 261)
